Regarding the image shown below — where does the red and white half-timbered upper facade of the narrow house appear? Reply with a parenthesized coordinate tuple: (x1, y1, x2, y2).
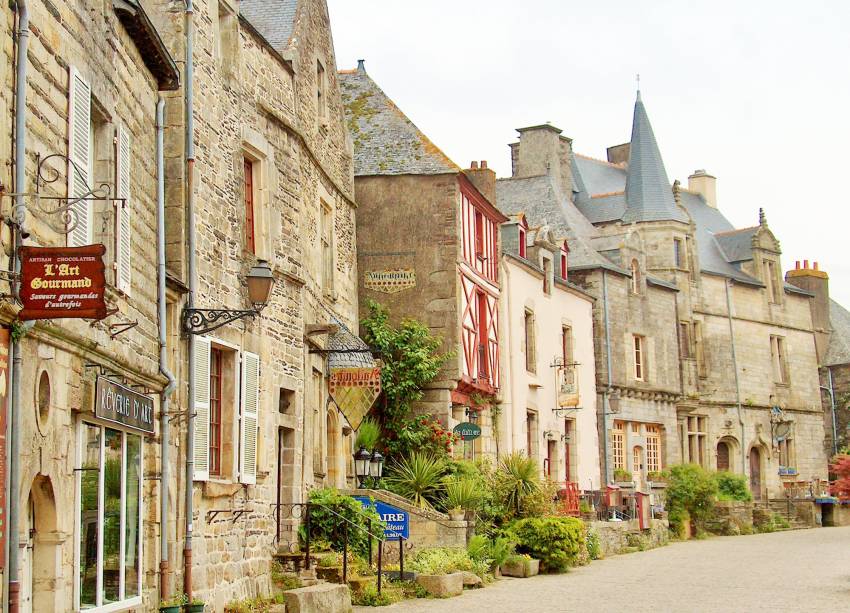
(458, 175, 507, 394)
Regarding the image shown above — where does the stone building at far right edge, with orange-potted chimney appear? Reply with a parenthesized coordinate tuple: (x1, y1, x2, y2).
(785, 260, 850, 457)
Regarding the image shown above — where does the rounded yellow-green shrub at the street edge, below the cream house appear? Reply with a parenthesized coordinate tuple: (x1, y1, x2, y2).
(510, 517, 586, 572)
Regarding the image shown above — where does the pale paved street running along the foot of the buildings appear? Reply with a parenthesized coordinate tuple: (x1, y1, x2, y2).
(362, 528, 850, 613)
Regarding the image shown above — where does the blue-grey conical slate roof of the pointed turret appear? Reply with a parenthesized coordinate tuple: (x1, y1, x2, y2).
(623, 91, 689, 223)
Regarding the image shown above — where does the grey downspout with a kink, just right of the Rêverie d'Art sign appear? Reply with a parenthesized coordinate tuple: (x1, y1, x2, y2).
(156, 96, 177, 600)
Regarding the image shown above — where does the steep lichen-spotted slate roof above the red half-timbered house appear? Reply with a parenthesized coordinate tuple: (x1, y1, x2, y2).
(339, 64, 461, 176)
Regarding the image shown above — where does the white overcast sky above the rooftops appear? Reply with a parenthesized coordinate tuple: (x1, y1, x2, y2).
(328, 0, 850, 308)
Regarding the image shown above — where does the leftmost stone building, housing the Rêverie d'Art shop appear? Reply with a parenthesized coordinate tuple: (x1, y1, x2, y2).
(0, 0, 179, 612)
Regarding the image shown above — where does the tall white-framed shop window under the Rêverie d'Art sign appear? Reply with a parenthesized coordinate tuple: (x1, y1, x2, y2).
(76, 422, 143, 609)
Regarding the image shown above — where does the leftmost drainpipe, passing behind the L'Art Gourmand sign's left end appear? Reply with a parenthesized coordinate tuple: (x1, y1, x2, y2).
(6, 0, 30, 613)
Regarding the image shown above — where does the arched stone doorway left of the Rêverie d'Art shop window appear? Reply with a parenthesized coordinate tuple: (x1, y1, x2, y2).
(21, 474, 67, 613)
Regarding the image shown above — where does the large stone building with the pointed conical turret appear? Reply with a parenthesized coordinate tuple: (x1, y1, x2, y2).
(498, 95, 826, 497)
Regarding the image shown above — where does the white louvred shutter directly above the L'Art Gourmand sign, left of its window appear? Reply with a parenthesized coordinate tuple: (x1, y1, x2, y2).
(68, 67, 93, 247)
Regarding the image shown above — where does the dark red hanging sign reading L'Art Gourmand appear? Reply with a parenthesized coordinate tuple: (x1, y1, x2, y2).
(18, 245, 106, 320)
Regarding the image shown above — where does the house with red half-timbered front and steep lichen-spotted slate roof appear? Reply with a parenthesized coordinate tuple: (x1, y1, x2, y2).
(340, 61, 506, 457)
